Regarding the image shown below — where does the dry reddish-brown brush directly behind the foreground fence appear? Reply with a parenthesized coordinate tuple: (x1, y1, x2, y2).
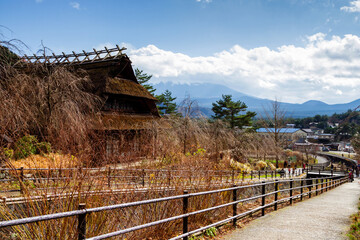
(0, 165, 236, 239)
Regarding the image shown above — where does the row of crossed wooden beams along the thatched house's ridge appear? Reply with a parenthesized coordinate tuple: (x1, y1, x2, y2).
(17, 45, 126, 65)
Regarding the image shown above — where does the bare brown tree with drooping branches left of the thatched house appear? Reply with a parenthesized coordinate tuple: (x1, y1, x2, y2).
(0, 57, 101, 154)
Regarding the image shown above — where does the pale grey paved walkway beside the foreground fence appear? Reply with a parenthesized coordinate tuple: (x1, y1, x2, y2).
(223, 178, 360, 240)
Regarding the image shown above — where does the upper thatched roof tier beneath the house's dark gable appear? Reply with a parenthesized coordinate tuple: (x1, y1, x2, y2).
(104, 78, 156, 101)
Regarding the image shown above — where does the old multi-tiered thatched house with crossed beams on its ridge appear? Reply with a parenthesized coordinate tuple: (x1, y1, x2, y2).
(16, 46, 160, 161)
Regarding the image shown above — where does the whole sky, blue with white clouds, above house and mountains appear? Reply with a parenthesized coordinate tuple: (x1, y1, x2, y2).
(0, 0, 360, 103)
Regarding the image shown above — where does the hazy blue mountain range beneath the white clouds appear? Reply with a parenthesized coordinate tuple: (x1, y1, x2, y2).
(154, 83, 360, 118)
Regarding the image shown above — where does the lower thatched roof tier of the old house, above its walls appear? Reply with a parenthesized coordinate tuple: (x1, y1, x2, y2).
(93, 113, 169, 130)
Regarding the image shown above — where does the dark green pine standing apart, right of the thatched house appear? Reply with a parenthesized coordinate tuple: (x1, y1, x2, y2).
(212, 95, 256, 128)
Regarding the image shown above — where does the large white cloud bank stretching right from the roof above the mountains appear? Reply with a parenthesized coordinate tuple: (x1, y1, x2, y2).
(127, 33, 360, 103)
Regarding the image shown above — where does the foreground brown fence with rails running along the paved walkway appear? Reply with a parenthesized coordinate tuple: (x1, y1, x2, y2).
(0, 174, 347, 240)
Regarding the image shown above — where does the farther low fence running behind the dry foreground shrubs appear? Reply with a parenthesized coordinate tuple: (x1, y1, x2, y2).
(0, 167, 310, 193)
